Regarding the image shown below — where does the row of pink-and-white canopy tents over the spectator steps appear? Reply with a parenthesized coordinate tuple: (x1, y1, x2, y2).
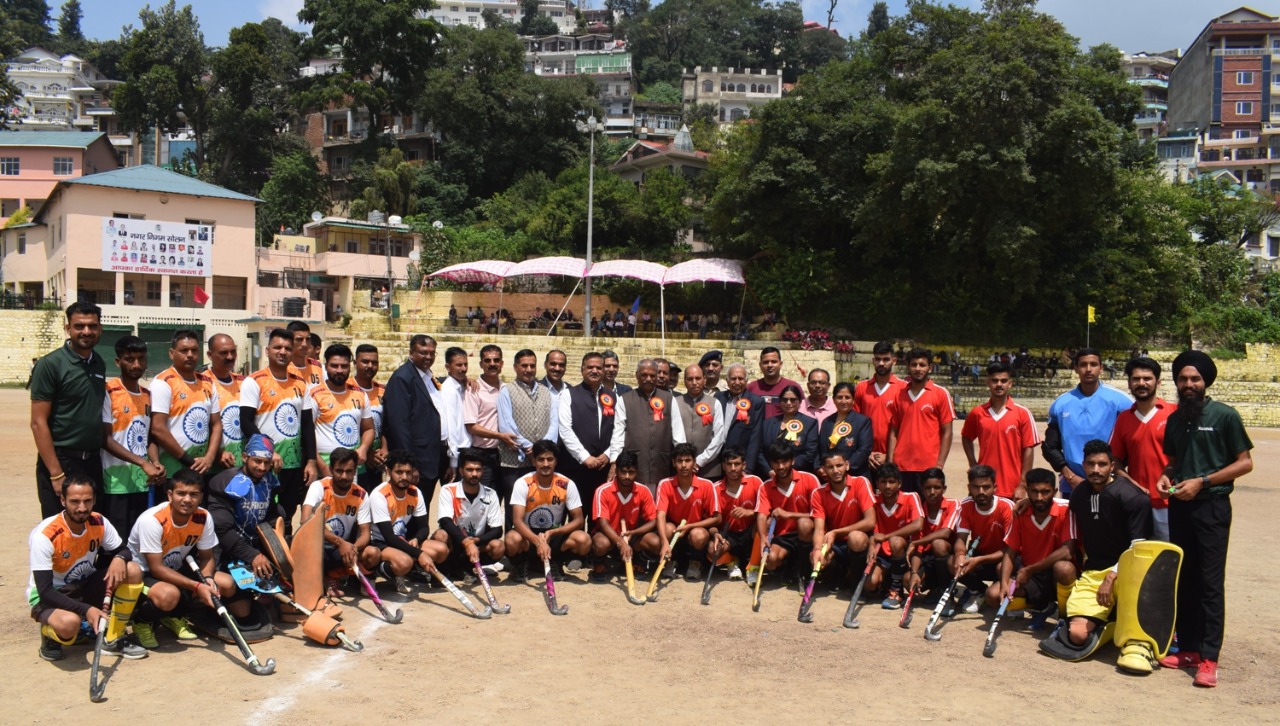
(428, 257, 746, 353)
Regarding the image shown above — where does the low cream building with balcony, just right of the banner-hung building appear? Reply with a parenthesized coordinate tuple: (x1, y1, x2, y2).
(257, 216, 421, 320)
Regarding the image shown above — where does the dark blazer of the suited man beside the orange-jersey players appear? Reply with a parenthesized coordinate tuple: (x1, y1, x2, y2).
(383, 361, 444, 481)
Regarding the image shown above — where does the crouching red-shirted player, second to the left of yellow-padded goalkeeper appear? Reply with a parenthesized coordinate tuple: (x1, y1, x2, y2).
(952, 464, 1014, 613)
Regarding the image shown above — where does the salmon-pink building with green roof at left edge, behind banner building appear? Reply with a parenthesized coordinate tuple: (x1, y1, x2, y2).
(0, 131, 120, 227)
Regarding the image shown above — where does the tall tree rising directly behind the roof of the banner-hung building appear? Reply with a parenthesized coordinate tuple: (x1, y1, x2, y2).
(111, 0, 214, 172)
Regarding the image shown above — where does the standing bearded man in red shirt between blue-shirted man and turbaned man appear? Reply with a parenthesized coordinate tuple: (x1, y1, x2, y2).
(1111, 357, 1178, 542)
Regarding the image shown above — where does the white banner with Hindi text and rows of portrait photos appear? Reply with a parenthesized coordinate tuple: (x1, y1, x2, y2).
(102, 218, 214, 278)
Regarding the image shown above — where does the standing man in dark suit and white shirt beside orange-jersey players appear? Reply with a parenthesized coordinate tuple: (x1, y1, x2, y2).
(383, 334, 453, 502)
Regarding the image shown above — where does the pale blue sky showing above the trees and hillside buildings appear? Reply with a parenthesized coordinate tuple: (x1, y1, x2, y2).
(77, 0, 1259, 52)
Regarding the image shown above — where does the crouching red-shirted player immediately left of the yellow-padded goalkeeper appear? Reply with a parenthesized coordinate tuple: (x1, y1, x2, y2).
(987, 469, 1076, 627)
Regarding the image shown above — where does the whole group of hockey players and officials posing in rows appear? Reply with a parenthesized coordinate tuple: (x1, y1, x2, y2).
(29, 303, 1252, 686)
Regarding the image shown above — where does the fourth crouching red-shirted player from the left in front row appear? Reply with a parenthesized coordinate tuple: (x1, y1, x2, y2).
(755, 440, 818, 571)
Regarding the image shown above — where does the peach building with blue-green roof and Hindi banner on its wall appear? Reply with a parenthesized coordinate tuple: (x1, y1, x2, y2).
(0, 165, 259, 370)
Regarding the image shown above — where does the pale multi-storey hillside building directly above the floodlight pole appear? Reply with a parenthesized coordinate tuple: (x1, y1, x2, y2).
(520, 33, 635, 136)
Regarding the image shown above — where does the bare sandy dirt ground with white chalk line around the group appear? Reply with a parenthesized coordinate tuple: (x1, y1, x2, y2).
(0, 391, 1280, 723)
